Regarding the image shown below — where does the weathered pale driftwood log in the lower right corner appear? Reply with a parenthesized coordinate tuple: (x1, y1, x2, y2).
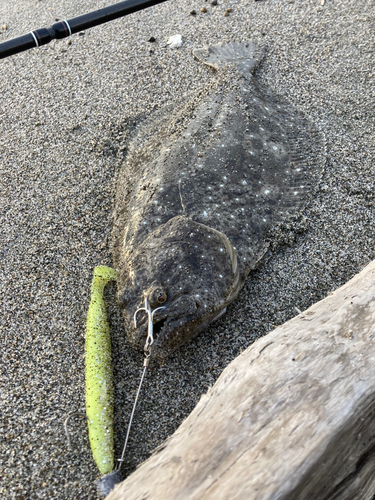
(107, 261, 375, 500)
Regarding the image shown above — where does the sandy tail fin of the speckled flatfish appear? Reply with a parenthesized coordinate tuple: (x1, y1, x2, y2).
(193, 42, 264, 76)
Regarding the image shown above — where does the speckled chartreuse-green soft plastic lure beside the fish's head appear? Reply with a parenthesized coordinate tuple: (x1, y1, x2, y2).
(86, 266, 116, 474)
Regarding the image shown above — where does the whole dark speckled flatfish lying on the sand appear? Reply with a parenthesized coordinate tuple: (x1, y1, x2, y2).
(113, 42, 324, 358)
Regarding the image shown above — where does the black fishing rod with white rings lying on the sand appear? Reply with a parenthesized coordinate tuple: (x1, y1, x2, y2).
(0, 0, 166, 59)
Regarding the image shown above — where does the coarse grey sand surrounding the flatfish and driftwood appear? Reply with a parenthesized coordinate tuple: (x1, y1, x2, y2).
(0, 0, 375, 500)
